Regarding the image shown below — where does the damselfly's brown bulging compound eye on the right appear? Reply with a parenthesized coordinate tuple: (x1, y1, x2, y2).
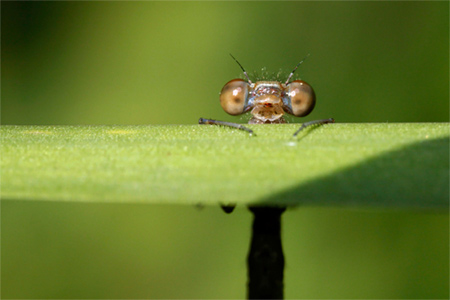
(287, 80, 316, 117)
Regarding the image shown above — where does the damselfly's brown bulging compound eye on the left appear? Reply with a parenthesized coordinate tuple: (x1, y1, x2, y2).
(220, 79, 248, 115)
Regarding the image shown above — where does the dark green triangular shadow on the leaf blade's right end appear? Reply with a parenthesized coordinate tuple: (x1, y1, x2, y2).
(258, 137, 449, 210)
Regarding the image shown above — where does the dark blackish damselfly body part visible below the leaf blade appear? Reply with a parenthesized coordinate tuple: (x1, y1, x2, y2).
(247, 207, 286, 299)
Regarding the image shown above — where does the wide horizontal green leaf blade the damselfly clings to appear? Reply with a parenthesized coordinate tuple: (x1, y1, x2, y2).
(0, 123, 449, 208)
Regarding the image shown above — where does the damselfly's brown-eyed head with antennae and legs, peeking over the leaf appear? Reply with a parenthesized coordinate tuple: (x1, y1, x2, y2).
(199, 56, 334, 136)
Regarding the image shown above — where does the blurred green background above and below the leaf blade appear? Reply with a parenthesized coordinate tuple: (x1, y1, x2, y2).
(1, 1, 449, 299)
